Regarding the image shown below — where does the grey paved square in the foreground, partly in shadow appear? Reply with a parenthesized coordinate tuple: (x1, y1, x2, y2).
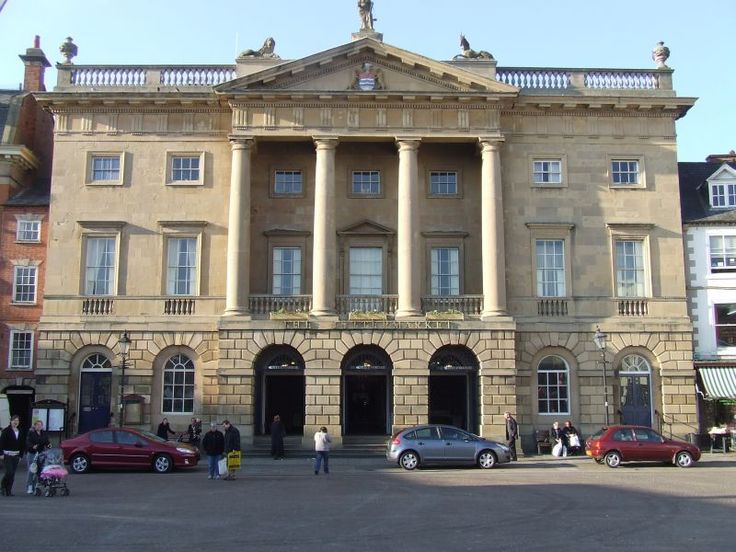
(0, 453, 736, 552)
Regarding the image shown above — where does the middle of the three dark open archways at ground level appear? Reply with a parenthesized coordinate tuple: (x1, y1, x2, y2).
(342, 345, 393, 435)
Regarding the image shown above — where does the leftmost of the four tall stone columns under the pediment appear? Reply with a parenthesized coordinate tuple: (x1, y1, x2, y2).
(225, 139, 254, 316)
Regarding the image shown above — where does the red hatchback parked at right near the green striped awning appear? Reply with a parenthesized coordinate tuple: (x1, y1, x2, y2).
(585, 426, 700, 468)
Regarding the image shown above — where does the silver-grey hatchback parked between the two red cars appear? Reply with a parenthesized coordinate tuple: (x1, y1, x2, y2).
(386, 424, 511, 470)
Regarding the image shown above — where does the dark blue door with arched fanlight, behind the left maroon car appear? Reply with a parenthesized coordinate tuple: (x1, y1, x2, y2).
(79, 353, 112, 433)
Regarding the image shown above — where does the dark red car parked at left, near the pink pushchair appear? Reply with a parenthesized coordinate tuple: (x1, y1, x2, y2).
(61, 428, 199, 473)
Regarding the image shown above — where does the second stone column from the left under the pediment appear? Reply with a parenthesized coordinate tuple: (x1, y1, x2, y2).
(310, 138, 338, 316)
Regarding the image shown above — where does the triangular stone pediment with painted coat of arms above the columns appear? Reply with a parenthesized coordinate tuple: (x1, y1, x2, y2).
(216, 38, 518, 96)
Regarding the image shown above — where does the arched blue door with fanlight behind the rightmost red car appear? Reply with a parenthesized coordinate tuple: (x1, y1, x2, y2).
(619, 355, 652, 427)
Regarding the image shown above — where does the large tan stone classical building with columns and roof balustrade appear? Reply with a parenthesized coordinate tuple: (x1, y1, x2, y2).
(38, 23, 696, 445)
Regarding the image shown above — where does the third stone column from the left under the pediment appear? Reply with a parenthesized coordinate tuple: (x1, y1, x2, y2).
(396, 139, 422, 318)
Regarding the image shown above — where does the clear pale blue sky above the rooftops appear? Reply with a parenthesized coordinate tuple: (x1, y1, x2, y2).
(0, 0, 736, 161)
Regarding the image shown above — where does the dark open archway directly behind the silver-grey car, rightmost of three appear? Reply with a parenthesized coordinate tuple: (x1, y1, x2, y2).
(429, 345, 478, 433)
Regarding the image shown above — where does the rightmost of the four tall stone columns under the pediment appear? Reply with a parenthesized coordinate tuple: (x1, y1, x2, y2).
(480, 140, 506, 319)
